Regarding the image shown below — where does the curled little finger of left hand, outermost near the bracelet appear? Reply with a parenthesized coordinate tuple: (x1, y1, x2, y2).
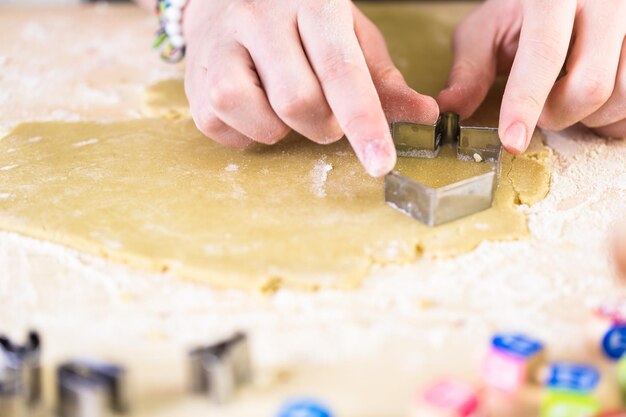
(185, 62, 252, 148)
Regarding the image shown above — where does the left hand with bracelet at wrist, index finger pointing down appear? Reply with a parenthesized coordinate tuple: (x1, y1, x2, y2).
(179, 0, 438, 176)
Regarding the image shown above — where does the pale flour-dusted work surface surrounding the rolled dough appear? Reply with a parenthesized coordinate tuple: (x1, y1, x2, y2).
(0, 1, 626, 417)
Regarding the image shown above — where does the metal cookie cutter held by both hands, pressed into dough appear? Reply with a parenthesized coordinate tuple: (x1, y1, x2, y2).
(385, 113, 502, 226)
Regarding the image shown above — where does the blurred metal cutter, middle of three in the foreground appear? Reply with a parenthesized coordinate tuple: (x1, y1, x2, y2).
(57, 360, 129, 417)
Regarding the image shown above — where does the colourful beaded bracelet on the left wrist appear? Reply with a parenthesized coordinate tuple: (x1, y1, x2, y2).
(152, 0, 187, 63)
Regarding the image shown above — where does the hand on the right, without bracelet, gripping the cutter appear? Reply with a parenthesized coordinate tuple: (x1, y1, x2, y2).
(437, 0, 626, 154)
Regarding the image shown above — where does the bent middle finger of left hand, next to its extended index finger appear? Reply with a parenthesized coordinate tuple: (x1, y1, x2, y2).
(242, 16, 343, 143)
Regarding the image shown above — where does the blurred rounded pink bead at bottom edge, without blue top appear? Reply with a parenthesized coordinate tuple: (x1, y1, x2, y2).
(414, 380, 479, 417)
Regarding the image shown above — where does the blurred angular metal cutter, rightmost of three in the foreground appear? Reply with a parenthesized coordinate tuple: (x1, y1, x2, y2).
(189, 333, 252, 404)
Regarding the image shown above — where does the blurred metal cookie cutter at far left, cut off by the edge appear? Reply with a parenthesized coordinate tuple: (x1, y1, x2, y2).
(0, 332, 41, 417)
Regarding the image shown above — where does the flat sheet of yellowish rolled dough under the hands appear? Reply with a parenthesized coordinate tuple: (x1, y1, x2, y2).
(0, 7, 550, 291)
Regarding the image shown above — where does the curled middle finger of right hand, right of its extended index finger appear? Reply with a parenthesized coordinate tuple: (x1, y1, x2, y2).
(539, 0, 626, 130)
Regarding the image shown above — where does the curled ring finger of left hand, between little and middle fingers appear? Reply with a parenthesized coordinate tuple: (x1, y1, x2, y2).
(206, 44, 289, 145)
